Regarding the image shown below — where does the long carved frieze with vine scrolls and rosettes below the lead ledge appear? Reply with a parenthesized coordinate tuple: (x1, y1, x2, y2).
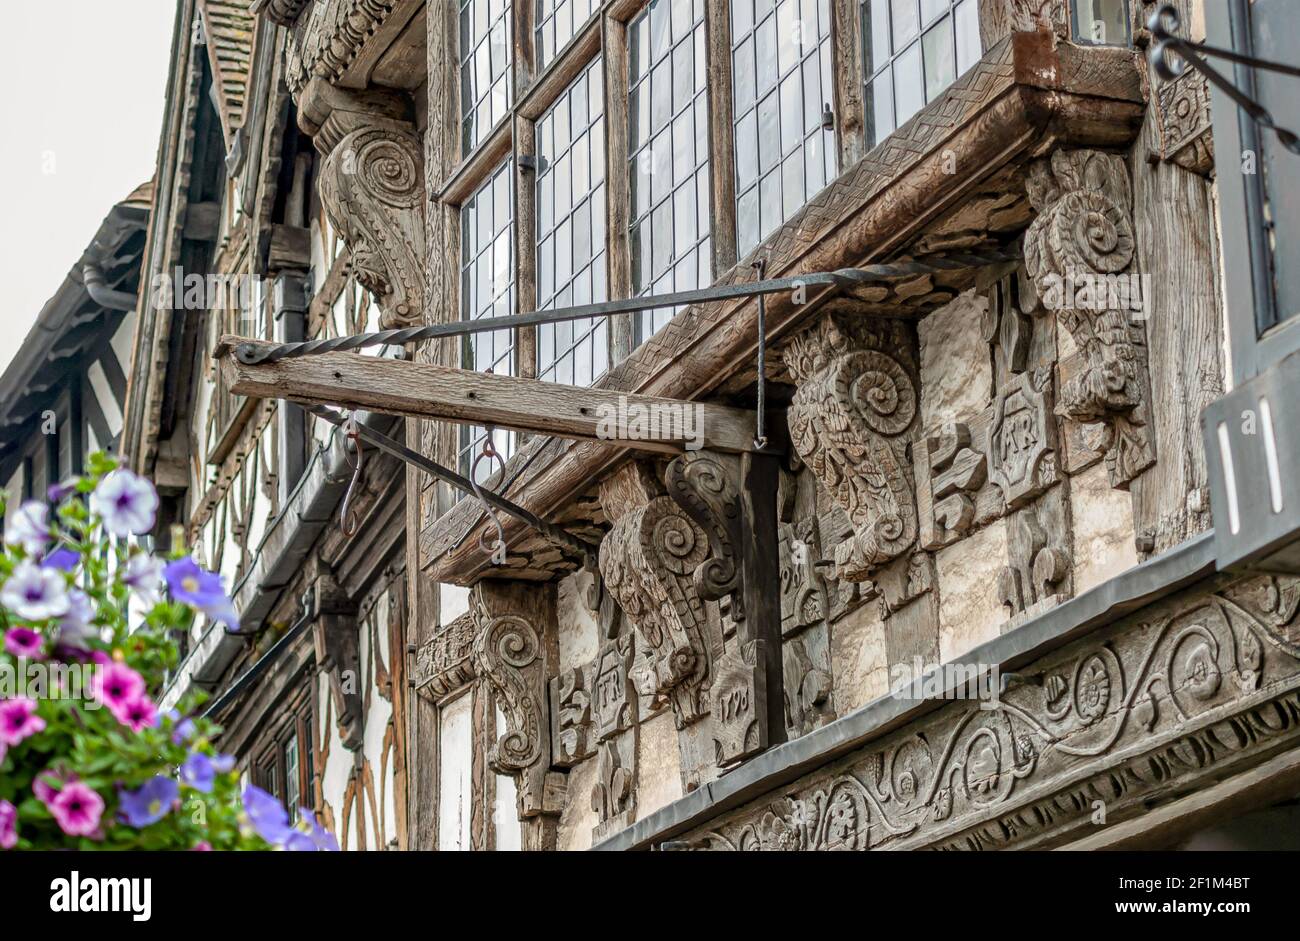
(676, 577, 1300, 850)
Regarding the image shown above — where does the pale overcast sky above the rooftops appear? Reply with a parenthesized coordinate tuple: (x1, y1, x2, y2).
(0, 0, 177, 372)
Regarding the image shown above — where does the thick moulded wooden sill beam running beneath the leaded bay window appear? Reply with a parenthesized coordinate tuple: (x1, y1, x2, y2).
(420, 32, 1144, 585)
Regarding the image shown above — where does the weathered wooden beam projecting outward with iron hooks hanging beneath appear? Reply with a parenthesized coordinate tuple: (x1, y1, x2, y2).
(215, 337, 757, 454)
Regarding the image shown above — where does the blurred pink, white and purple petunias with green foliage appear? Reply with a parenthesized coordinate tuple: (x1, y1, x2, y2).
(0, 454, 338, 850)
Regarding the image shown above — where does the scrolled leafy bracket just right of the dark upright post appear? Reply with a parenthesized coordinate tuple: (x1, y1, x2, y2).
(784, 307, 918, 581)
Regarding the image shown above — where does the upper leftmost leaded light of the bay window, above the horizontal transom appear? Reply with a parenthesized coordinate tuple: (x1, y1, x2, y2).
(460, 0, 514, 153)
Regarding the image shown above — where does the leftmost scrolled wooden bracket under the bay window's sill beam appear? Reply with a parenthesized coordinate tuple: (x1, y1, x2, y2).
(471, 581, 563, 820)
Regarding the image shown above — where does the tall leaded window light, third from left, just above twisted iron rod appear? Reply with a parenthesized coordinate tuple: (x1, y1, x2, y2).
(628, 0, 712, 339)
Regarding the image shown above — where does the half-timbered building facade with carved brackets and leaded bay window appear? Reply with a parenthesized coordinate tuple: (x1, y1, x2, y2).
(124, 0, 1300, 850)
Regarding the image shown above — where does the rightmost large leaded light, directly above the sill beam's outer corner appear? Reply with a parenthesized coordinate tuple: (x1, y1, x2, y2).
(862, 0, 980, 147)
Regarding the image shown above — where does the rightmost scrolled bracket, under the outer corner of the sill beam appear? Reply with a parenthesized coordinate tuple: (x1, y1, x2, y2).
(1024, 151, 1156, 489)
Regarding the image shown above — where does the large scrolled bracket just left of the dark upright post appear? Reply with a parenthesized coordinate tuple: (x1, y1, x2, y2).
(601, 461, 722, 728)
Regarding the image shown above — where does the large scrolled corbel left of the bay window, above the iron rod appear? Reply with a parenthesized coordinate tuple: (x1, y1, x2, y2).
(298, 78, 425, 329)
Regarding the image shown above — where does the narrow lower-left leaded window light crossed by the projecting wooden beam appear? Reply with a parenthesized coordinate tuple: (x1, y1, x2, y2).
(458, 162, 516, 480)
